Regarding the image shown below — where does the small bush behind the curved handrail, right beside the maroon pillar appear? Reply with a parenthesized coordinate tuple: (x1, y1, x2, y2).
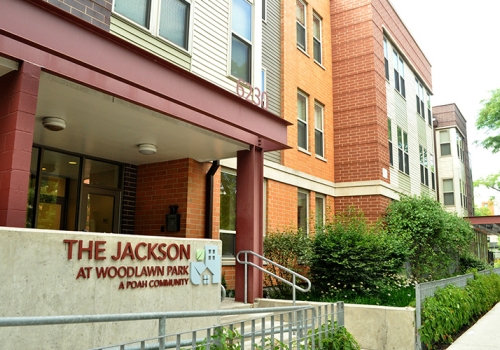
(264, 228, 312, 299)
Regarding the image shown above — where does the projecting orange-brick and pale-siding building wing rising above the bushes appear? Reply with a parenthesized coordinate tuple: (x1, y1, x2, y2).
(331, 0, 436, 220)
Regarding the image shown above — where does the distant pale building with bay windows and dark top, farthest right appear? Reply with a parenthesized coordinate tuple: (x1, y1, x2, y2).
(432, 103, 474, 217)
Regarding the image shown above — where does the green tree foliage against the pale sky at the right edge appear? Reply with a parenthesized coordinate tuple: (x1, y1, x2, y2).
(476, 89, 500, 153)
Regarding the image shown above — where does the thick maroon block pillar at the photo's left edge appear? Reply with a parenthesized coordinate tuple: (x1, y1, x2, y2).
(0, 62, 41, 227)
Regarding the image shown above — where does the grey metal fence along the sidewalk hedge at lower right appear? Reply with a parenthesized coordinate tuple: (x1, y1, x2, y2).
(415, 267, 500, 350)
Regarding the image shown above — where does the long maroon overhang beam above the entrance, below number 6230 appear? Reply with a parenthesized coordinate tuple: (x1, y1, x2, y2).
(0, 0, 291, 151)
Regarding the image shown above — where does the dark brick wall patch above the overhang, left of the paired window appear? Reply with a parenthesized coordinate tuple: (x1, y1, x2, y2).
(43, 0, 113, 32)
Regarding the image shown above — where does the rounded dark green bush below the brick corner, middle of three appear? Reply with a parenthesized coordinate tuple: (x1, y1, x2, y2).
(311, 208, 406, 295)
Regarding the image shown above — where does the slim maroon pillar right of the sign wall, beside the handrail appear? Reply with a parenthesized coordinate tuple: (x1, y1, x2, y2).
(235, 147, 264, 303)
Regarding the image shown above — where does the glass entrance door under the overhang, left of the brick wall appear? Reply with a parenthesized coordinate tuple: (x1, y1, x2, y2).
(80, 186, 120, 233)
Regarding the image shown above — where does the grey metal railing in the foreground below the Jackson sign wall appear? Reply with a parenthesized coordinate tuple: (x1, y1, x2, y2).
(0, 302, 344, 350)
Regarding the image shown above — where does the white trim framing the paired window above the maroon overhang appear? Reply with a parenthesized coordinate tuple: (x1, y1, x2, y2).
(112, 0, 194, 55)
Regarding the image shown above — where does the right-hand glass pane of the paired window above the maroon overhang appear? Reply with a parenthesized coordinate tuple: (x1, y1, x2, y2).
(160, 0, 189, 49)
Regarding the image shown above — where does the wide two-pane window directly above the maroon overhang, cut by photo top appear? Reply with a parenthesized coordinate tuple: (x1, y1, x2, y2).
(114, 0, 191, 50)
